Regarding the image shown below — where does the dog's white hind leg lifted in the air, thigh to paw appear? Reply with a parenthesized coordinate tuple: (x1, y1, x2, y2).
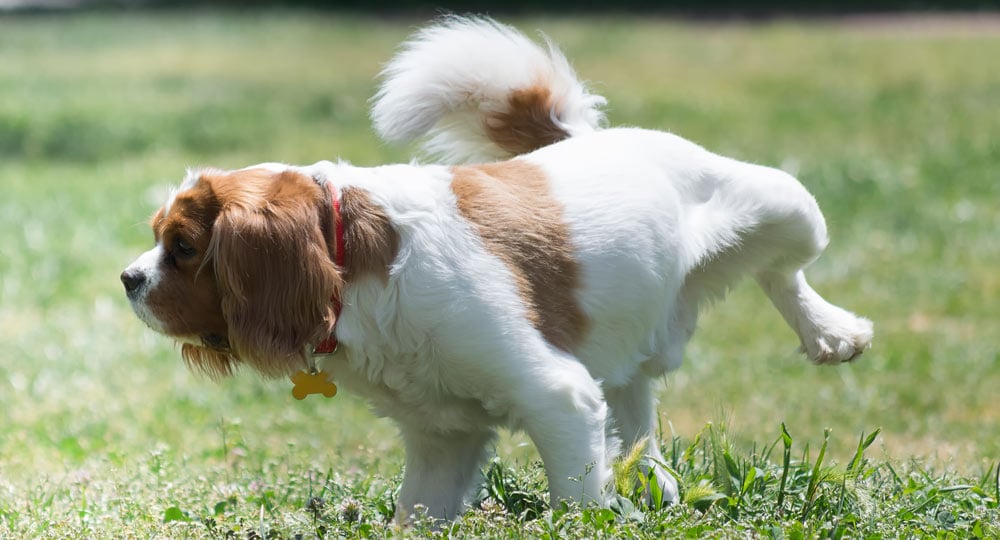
(685, 160, 872, 364)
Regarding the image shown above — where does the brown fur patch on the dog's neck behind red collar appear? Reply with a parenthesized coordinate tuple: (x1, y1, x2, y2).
(340, 187, 399, 283)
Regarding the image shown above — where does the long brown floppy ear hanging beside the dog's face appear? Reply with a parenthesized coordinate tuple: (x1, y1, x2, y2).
(212, 199, 342, 377)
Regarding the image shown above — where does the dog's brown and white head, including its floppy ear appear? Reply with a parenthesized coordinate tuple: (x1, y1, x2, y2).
(121, 168, 342, 376)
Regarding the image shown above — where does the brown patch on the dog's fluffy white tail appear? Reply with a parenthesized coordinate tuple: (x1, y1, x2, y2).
(483, 84, 569, 156)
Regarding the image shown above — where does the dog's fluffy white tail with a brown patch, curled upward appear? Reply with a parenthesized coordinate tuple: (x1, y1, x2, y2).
(372, 17, 605, 163)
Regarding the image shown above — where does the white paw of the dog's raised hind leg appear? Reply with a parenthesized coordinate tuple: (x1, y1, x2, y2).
(801, 306, 873, 364)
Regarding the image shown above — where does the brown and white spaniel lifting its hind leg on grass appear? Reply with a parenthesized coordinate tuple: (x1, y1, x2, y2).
(121, 17, 872, 523)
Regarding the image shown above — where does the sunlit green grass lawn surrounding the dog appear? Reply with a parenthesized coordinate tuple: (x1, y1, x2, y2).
(0, 12, 1000, 538)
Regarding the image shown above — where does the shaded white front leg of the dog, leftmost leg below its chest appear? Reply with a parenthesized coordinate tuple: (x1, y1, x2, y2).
(394, 426, 494, 525)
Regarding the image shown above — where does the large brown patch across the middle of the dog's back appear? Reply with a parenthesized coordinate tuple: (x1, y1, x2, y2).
(451, 160, 588, 351)
